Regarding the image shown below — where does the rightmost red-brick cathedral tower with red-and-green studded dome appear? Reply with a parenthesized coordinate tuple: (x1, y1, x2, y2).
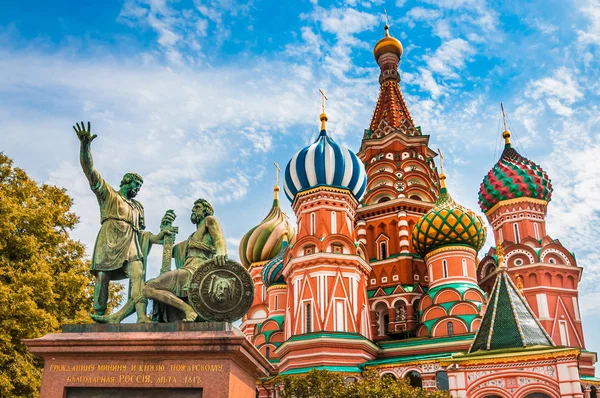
(478, 112, 586, 366)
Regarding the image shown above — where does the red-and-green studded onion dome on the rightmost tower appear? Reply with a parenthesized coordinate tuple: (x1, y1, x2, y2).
(479, 130, 552, 213)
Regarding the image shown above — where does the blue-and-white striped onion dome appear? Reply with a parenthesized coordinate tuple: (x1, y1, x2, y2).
(284, 129, 367, 202)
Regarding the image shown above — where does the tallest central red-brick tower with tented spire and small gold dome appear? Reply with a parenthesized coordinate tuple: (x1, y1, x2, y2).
(356, 25, 439, 340)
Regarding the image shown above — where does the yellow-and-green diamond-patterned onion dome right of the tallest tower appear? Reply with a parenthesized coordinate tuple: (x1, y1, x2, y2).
(412, 171, 486, 258)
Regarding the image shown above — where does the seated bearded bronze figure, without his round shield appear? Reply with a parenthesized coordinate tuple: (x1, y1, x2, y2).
(143, 199, 228, 322)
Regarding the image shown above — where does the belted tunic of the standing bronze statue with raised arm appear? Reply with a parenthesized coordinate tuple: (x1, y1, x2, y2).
(91, 177, 145, 280)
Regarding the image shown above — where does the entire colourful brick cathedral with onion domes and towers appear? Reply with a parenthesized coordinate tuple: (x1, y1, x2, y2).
(239, 26, 600, 398)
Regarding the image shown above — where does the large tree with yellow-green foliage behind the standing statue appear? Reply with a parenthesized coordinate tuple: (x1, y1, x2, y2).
(0, 152, 120, 397)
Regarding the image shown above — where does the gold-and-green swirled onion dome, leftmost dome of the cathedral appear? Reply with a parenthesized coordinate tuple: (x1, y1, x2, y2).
(239, 185, 296, 268)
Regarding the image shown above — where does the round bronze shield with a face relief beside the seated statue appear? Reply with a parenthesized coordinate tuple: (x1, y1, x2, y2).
(188, 260, 254, 322)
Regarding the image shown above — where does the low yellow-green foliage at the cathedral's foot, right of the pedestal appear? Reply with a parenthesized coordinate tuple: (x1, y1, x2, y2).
(268, 369, 450, 398)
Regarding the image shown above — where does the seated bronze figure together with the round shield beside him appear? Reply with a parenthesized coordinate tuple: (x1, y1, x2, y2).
(143, 199, 253, 322)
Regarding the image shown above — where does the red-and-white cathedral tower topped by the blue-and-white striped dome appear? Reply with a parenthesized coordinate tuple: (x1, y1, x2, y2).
(277, 112, 376, 373)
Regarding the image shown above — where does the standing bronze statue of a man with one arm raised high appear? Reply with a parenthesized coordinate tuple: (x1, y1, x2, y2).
(73, 122, 175, 323)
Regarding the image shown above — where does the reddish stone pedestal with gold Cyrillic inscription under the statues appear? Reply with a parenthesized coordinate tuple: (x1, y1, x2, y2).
(25, 323, 274, 398)
